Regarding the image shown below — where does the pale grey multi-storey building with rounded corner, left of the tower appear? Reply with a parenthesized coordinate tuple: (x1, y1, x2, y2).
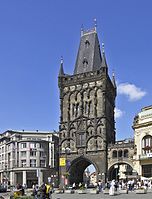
(0, 130, 58, 187)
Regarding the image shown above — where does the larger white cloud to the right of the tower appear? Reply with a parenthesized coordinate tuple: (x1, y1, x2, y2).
(117, 83, 146, 101)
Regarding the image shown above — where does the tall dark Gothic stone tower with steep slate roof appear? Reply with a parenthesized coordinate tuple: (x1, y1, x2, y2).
(58, 28, 116, 184)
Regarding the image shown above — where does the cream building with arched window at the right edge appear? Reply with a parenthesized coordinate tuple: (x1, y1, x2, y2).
(133, 106, 152, 178)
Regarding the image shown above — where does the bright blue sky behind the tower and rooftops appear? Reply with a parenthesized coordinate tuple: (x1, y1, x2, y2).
(0, 0, 152, 139)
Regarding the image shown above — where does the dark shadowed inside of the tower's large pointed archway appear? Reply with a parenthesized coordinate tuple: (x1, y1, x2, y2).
(69, 156, 99, 185)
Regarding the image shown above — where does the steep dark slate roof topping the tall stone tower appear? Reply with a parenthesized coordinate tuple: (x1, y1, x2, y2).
(74, 25, 102, 74)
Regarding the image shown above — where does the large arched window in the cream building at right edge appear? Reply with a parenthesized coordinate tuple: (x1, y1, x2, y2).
(142, 135, 152, 154)
